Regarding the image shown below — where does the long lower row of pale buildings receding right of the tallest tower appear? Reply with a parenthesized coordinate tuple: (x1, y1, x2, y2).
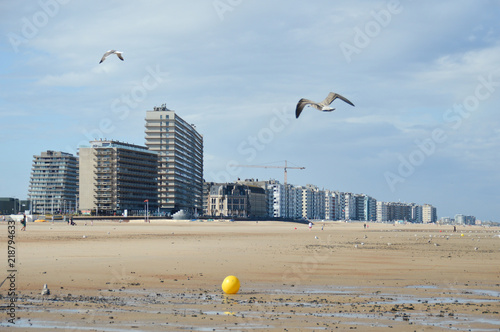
(203, 179, 437, 223)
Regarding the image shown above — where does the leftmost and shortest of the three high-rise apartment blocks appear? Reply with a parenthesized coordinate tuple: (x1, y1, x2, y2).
(28, 150, 78, 214)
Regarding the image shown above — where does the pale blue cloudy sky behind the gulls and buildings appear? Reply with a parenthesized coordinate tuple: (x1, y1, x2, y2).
(0, 0, 500, 221)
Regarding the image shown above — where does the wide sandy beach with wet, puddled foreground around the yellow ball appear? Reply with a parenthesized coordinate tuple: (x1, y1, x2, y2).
(0, 221, 500, 331)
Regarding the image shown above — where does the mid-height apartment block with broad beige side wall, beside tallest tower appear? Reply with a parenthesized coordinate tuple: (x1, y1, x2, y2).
(79, 140, 158, 215)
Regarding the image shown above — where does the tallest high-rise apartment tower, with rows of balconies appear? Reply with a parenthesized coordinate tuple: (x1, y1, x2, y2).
(146, 105, 203, 214)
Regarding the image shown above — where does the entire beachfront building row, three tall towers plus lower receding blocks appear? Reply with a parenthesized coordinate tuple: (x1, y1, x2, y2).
(6, 105, 437, 223)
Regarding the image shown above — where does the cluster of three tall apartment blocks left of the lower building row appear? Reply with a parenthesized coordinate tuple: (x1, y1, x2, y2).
(28, 105, 203, 215)
